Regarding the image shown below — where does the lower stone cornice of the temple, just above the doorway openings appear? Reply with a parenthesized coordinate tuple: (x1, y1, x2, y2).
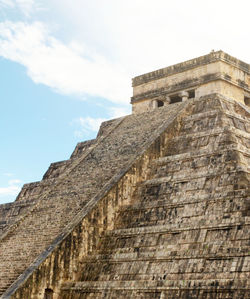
(131, 73, 250, 104)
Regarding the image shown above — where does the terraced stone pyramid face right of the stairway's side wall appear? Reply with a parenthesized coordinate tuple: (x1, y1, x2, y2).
(60, 98, 250, 299)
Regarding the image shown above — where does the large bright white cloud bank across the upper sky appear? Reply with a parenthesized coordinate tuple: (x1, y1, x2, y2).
(0, 0, 250, 103)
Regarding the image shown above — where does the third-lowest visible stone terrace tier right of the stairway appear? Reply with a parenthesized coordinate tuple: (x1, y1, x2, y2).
(97, 236, 250, 258)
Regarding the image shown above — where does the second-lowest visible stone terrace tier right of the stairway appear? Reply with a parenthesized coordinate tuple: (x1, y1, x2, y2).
(76, 256, 250, 281)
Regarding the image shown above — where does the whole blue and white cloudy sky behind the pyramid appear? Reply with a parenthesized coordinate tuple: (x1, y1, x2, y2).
(0, 0, 250, 204)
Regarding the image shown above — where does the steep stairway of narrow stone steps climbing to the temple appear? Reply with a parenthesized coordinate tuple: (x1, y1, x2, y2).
(0, 103, 187, 298)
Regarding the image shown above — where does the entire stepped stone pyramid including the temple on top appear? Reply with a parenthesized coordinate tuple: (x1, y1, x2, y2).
(0, 51, 250, 299)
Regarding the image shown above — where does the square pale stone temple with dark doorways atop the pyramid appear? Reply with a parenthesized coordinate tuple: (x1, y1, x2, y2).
(131, 51, 250, 113)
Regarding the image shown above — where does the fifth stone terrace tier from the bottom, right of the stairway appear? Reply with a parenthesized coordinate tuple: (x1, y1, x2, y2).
(136, 176, 249, 209)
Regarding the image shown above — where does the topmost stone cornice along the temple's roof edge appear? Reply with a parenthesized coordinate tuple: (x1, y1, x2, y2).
(132, 51, 250, 87)
